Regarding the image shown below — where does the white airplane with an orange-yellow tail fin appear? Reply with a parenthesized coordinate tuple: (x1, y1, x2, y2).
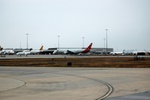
(16, 46, 43, 56)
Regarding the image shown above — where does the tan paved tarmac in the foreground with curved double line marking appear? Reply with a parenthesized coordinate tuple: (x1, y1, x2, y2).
(0, 66, 150, 100)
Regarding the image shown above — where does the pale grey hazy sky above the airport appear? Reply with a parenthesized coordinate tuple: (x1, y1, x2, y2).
(0, 0, 150, 51)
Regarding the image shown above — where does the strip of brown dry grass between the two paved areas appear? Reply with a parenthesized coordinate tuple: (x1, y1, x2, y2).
(0, 57, 150, 68)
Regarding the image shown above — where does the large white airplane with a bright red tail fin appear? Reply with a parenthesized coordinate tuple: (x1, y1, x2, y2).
(53, 43, 93, 54)
